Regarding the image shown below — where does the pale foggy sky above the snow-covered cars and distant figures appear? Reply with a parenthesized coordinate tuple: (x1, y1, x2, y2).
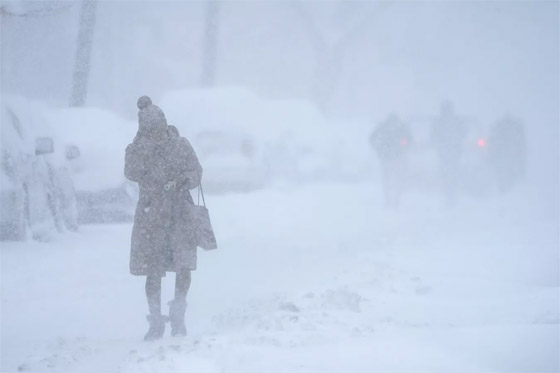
(1, 1, 560, 203)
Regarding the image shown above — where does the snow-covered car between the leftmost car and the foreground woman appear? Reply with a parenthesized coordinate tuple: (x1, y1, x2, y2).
(46, 107, 138, 224)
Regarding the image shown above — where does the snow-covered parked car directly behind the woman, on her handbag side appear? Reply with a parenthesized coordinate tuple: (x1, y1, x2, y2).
(159, 88, 267, 193)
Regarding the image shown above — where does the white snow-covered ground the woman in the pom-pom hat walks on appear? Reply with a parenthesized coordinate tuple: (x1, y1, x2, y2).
(0, 183, 560, 372)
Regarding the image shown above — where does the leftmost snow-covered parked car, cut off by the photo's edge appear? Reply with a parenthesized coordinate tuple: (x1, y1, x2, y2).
(0, 98, 78, 241)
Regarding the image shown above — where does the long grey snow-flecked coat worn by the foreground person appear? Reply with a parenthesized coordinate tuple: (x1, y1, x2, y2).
(124, 132, 202, 276)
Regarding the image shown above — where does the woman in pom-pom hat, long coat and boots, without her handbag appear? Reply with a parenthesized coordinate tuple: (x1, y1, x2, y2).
(124, 96, 202, 341)
